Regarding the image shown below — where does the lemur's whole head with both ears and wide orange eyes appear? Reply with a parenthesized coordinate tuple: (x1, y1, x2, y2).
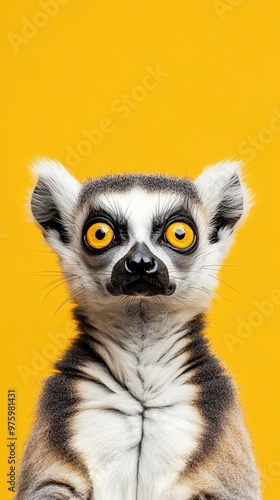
(31, 160, 250, 311)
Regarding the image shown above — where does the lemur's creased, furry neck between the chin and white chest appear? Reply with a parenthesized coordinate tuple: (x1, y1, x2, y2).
(72, 300, 208, 402)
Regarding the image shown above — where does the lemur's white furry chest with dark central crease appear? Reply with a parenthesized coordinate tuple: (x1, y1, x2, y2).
(72, 354, 201, 500)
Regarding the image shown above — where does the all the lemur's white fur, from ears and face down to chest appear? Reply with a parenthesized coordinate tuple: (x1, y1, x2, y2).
(27, 162, 254, 500)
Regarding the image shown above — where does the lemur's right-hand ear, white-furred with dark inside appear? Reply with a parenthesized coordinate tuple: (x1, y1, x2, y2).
(195, 161, 251, 243)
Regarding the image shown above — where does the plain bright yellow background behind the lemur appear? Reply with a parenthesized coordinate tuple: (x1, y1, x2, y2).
(0, 0, 280, 500)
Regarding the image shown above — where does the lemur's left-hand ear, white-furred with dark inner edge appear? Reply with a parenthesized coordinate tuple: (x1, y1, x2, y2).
(31, 159, 81, 244)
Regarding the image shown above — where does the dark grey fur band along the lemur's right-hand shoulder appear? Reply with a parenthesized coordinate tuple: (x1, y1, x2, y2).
(180, 315, 235, 470)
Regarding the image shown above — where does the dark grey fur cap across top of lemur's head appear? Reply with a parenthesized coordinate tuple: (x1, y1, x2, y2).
(79, 174, 199, 204)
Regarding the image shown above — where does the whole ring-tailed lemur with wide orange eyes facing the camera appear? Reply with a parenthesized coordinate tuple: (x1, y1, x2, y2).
(15, 159, 261, 500)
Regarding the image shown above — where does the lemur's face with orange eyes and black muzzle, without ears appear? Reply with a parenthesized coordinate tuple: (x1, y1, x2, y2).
(80, 187, 199, 296)
